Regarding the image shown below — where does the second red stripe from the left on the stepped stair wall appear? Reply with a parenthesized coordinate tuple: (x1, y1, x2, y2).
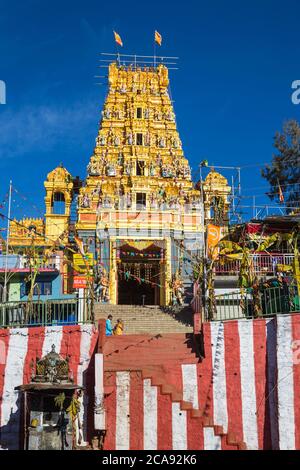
(129, 371, 144, 450)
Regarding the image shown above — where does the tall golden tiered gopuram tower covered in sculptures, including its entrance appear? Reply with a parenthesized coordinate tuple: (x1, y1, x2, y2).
(77, 57, 204, 306)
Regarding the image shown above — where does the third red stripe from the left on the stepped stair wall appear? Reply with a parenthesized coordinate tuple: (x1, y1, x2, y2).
(157, 387, 172, 450)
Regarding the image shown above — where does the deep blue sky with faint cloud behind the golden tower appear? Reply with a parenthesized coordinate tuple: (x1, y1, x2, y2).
(0, 0, 300, 223)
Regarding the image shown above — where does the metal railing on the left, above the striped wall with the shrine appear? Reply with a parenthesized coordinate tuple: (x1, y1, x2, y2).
(0, 298, 93, 328)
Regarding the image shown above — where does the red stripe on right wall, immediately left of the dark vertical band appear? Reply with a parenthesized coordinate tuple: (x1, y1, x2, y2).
(253, 319, 272, 449)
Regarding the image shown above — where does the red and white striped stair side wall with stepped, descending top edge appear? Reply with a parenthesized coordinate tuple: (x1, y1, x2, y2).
(104, 371, 237, 450)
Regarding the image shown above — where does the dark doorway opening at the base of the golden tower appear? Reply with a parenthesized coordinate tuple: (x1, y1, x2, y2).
(117, 243, 162, 305)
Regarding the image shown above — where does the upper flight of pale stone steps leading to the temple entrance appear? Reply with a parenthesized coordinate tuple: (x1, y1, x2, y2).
(95, 303, 193, 334)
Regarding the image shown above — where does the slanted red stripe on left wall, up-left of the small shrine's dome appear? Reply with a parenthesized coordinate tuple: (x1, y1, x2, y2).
(23, 327, 45, 384)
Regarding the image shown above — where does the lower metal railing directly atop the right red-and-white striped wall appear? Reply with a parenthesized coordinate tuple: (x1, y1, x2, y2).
(211, 285, 300, 320)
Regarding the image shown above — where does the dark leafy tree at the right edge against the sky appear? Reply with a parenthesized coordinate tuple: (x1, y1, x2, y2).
(262, 120, 300, 213)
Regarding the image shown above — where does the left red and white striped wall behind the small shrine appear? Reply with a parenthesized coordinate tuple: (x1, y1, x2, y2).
(0, 325, 98, 449)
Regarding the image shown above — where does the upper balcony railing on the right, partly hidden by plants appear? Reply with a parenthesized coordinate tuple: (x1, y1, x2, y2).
(215, 253, 294, 275)
